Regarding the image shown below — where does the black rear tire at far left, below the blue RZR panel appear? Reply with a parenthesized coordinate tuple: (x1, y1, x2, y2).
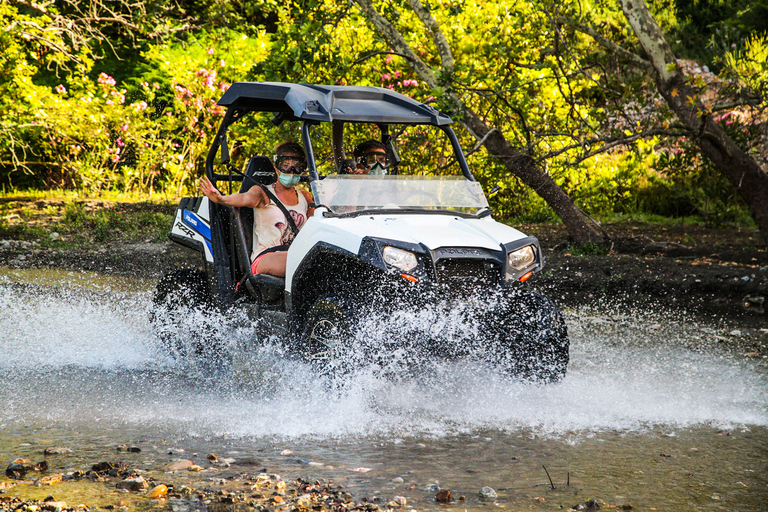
(149, 269, 219, 357)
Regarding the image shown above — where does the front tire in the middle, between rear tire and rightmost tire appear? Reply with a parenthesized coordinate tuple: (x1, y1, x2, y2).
(299, 297, 355, 376)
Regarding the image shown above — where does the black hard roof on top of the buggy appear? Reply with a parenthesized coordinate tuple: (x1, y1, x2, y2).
(219, 82, 452, 126)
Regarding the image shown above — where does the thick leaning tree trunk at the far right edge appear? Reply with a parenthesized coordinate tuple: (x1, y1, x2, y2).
(621, 0, 768, 240)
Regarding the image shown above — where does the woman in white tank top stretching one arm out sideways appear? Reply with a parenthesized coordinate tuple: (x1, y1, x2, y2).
(200, 142, 315, 277)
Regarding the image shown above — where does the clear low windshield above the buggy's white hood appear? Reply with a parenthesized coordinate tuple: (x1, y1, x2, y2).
(312, 174, 488, 215)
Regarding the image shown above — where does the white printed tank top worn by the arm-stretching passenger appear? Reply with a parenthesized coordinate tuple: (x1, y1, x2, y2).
(251, 185, 309, 261)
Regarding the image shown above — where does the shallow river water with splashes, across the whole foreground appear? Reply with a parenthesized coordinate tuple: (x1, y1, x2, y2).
(0, 269, 768, 511)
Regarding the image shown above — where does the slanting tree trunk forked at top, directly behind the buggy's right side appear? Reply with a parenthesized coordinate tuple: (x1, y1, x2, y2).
(355, 0, 607, 245)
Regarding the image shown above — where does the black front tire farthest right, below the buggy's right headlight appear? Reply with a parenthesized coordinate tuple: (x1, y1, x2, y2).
(490, 292, 570, 384)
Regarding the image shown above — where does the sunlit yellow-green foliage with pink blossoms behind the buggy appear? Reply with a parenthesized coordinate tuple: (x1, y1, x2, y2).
(0, 0, 768, 232)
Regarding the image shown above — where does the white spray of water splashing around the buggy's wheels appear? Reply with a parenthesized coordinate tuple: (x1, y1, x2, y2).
(0, 272, 768, 438)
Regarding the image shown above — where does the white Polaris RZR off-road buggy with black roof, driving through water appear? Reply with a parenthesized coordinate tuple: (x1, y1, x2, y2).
(151, 83, 569, 381)
